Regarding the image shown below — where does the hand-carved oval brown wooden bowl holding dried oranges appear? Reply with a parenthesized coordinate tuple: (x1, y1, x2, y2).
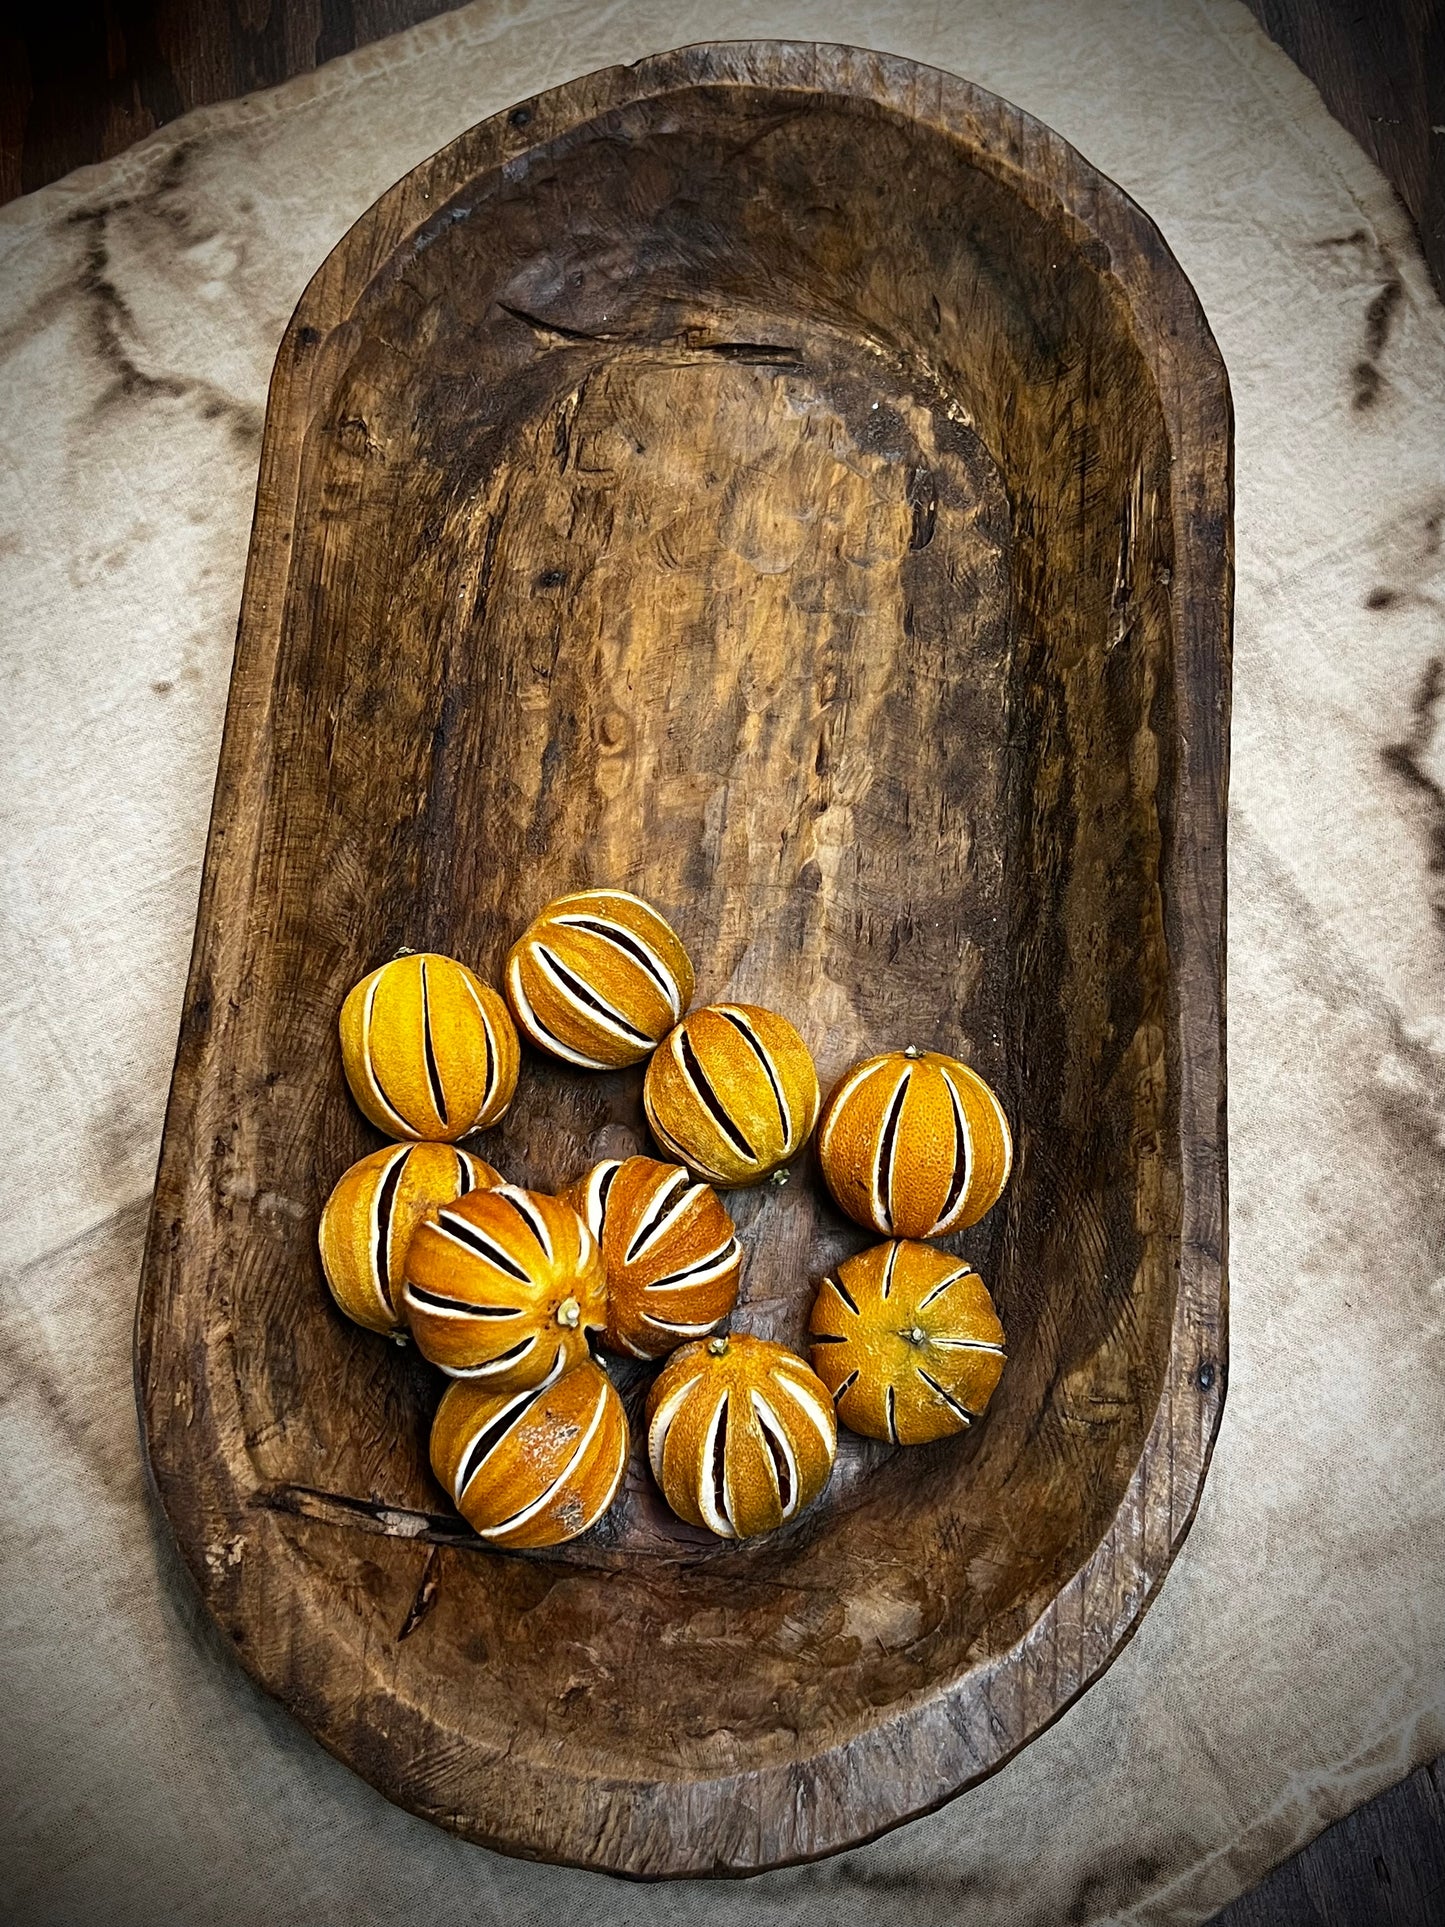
(137, 44, 1231, 1875)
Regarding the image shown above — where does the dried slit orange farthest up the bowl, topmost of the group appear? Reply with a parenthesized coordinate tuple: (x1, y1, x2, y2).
(505, 890, 692, 1071)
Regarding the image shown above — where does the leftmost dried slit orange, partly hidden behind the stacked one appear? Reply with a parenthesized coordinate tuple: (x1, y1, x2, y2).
(318, 1145, 503, 1333)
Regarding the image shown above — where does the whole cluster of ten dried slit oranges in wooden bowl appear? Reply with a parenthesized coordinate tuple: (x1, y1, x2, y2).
(320, 890, 1012, 1547)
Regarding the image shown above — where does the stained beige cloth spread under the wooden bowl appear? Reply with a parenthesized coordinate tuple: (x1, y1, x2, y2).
(0, 0, 1445, 1927)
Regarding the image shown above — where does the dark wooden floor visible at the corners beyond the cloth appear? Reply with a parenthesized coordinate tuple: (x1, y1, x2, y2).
(0, 0, 1445, 1927)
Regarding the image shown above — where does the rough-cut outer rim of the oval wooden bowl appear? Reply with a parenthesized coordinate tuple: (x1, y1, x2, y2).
(135, 42, 1233, 1879)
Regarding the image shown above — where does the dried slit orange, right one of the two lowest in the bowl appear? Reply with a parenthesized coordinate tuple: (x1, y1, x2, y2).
(647, 1333, 838, 1540)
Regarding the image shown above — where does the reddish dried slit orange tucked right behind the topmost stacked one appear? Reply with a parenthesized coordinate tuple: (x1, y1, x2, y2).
(566, 1158, 742, 1359)
